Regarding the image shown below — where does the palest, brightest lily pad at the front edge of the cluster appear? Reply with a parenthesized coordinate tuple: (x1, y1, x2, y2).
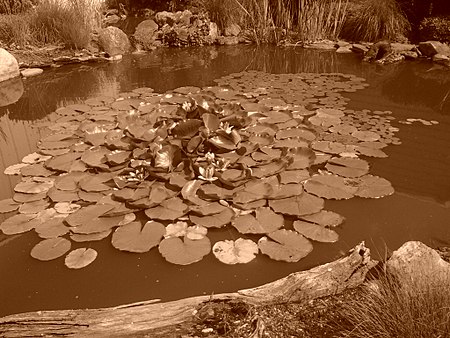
(212, 238, 259, 264)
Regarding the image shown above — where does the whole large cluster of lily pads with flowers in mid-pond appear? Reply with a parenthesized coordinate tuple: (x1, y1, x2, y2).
(0, 72, 400, 268)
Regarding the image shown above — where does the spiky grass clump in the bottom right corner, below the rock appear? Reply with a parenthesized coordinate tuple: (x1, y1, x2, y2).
(340, 274, 450, 338)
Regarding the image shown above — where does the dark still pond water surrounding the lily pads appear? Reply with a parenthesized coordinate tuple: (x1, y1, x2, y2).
(0, 46, 450, 316)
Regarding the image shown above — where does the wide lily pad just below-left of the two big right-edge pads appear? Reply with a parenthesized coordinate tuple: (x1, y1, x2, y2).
(269, 192, 324, 216)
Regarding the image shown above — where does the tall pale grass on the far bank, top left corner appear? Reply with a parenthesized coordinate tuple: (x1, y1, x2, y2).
(0, 0, 101, 49)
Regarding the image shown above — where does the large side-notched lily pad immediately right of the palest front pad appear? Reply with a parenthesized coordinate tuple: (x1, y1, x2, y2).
(258, 229, 313, 262)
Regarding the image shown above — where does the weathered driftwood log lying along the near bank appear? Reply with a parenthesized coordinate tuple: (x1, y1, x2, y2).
(0, 243, 376, 337)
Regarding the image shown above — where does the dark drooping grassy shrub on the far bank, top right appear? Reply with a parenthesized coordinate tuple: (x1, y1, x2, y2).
(341, 0, 411, 42)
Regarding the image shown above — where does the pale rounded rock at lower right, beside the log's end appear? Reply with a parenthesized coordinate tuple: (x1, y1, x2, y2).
(386, 241, 450, 285)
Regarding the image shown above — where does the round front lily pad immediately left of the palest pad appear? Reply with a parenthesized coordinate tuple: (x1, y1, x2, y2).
(158, 237, 211, 265)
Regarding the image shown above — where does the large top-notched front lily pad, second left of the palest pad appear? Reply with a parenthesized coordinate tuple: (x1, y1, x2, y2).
(111, 221, 166, 252)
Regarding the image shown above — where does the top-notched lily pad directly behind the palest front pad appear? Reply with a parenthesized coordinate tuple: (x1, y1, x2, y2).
(231, 208, 284, 234)
